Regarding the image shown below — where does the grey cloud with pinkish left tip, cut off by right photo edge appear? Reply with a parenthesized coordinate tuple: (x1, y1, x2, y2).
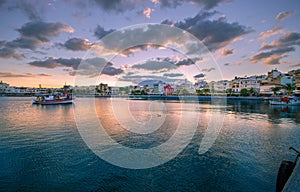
(261, 32, 300, 50)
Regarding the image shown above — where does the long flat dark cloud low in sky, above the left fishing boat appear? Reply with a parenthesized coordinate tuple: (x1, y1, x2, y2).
(28, 57, 81, 69)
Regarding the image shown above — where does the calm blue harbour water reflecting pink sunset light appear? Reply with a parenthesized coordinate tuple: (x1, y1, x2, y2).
(0, 97, 300, 192)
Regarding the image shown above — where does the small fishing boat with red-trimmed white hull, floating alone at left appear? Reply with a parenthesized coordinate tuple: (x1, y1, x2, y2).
(32, 94, 75, 105)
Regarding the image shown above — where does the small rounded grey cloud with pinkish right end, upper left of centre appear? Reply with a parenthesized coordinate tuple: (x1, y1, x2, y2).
(63, 38, 92, 51)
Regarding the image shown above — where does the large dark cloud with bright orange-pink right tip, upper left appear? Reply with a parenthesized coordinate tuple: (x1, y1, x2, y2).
(17, 21, 74, 42)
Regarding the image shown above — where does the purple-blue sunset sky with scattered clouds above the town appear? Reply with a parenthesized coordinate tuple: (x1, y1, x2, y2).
(0, 0, 300, 87)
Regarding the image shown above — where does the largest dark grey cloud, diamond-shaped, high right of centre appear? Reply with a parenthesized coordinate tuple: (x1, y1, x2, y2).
(162, 12, 253, 50)
